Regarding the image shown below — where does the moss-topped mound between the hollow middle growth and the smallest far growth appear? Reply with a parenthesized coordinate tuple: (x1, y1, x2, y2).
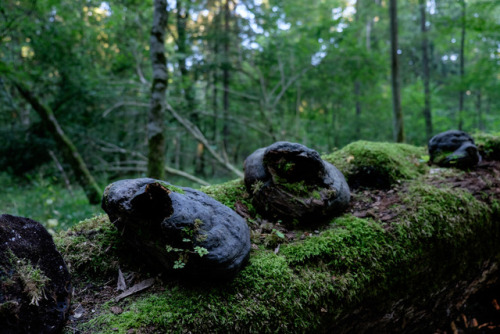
(322, 141, 427, 188)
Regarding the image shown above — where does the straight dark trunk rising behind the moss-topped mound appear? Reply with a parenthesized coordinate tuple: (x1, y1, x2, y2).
(389, 0, 405, 143)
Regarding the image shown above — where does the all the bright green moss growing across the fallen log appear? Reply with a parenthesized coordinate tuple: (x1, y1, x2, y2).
(61, 142, 500, 333)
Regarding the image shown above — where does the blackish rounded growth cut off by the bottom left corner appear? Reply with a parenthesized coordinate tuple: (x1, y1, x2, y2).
(0, 215, 72, 333)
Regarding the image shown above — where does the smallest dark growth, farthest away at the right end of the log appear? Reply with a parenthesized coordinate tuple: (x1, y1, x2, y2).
(428, 130, 481, 168)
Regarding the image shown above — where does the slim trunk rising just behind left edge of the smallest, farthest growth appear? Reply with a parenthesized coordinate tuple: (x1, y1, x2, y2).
(419, 0, 433, 139)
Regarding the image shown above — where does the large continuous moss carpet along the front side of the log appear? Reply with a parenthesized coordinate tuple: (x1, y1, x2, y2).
(63, 183, 500, 333)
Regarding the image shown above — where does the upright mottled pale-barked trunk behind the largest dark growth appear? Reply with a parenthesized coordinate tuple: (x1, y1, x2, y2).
(147, 0, 168, 180)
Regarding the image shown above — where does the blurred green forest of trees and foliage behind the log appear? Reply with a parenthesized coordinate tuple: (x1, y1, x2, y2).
(0, 0, 500, 229)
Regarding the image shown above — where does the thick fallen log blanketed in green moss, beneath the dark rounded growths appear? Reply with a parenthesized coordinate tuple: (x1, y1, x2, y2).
(56, 137, 500, 333)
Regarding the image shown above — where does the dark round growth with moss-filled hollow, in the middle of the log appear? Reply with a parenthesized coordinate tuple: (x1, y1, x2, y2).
(245, 142, 350, 222)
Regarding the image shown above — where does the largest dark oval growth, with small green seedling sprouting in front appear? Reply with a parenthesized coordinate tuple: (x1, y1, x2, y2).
(102, 178, 250, 280)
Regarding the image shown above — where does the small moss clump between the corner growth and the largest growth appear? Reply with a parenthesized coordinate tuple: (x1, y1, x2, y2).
(54, 215, 121, 278)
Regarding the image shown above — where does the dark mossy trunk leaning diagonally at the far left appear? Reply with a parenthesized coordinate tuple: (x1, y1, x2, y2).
(14, 82, 101, 204)
